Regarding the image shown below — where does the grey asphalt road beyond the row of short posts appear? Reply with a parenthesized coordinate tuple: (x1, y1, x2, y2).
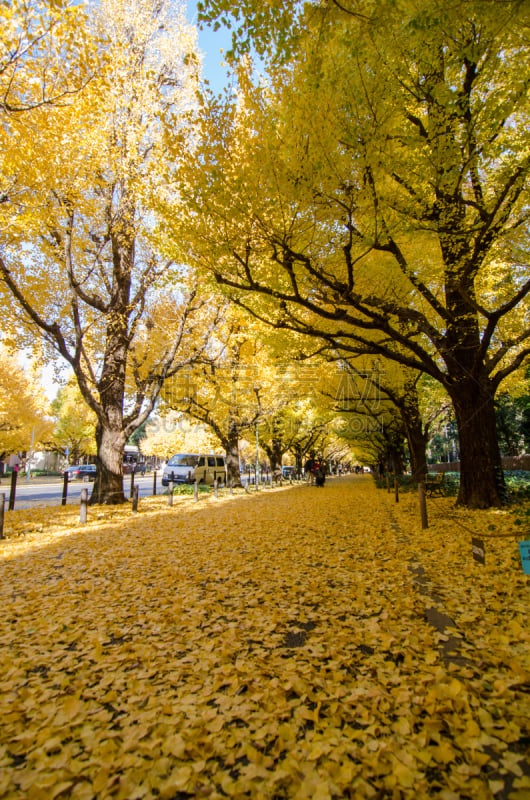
(0, 473, 157, 510)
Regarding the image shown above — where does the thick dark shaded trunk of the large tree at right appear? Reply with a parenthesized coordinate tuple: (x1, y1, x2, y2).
(449, 378, 506, 508)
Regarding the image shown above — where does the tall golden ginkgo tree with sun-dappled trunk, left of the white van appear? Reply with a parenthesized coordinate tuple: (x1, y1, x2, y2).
(0, 0, 222, 503)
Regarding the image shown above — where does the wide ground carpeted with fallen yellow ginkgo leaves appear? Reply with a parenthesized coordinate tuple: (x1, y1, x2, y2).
(0, 476, 530, 800)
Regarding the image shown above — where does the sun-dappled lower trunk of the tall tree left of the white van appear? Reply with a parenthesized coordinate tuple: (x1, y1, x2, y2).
(89, 423, 126, 505)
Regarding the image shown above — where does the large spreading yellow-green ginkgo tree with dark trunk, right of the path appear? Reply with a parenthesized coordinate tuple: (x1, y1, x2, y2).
(168, 0, 530, 507)
